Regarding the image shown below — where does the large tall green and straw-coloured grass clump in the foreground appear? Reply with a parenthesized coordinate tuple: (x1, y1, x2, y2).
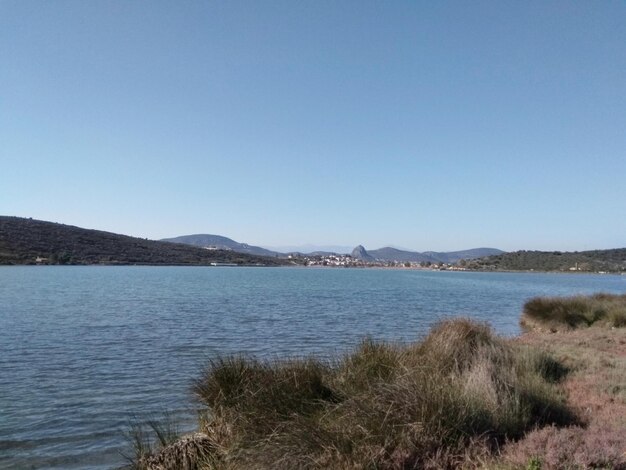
(188, 319, 574, 469)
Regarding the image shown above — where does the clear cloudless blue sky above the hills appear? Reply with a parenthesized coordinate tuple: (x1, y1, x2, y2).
(0, 0, 626, 251)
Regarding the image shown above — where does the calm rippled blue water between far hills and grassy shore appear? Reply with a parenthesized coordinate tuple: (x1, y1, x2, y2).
(0, 266, 626, 469)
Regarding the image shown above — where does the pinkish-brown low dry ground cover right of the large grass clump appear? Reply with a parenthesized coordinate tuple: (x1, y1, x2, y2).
(494, 326, 626, 470)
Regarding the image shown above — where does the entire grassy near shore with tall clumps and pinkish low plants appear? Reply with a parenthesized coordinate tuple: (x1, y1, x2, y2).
(123, 294, 626, 470)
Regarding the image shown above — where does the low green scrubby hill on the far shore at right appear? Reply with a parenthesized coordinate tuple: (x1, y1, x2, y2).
(465, 248, 626, 272)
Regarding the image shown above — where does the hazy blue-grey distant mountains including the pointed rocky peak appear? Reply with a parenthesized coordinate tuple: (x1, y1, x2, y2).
(352, 245, 504, 264)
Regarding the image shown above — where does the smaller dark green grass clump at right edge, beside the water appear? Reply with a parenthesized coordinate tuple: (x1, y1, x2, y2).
(520, 293, 626, 331)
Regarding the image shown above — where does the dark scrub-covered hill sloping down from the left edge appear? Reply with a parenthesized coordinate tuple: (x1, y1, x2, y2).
(0, 216, 281, 265)
